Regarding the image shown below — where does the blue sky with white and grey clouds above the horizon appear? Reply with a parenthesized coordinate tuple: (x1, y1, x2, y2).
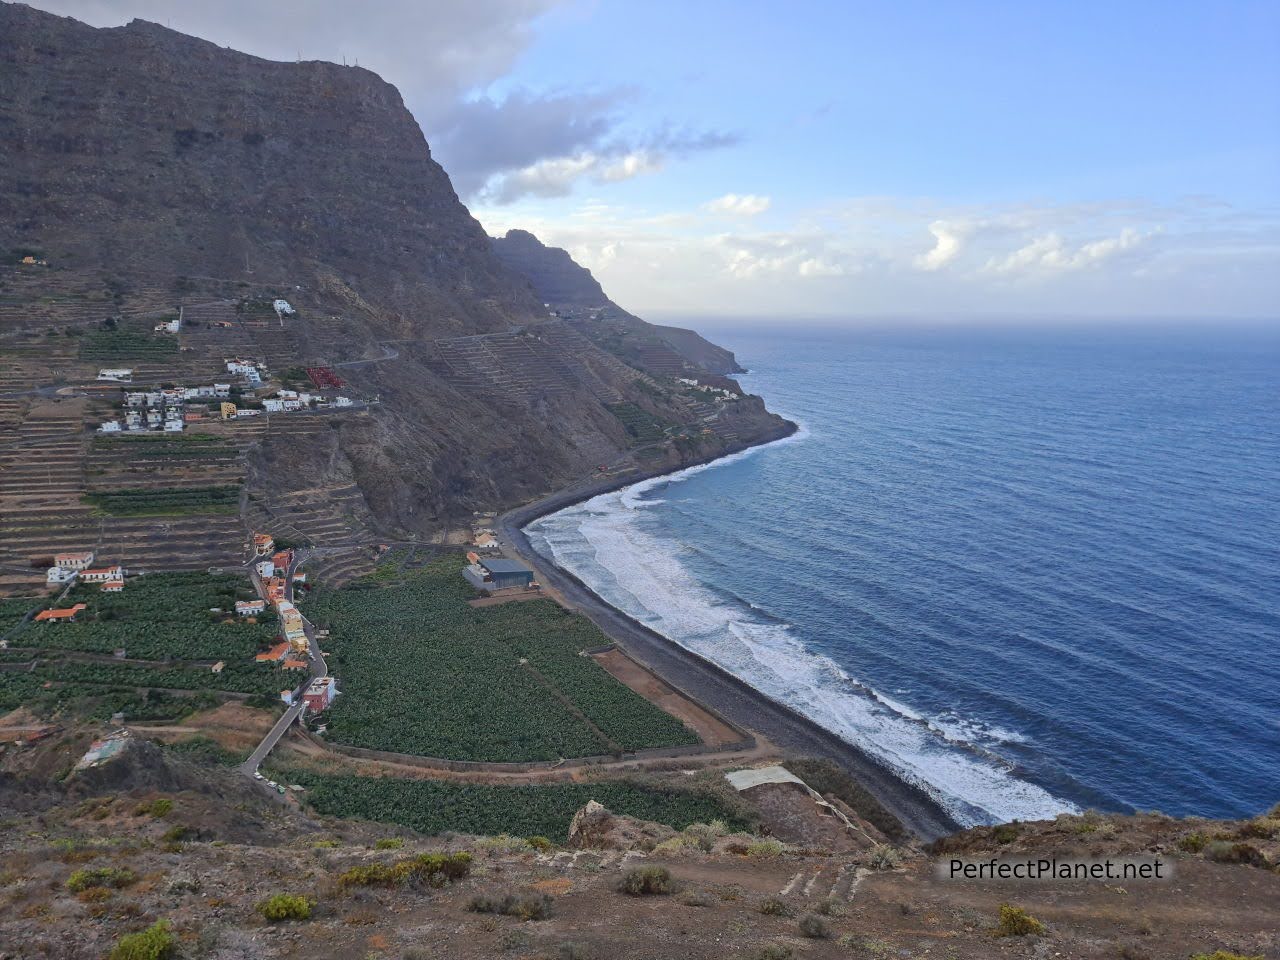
(20, 0, 1280, 323)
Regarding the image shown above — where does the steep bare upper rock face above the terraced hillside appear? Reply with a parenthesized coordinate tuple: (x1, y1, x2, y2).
(0, 4, 543, 333)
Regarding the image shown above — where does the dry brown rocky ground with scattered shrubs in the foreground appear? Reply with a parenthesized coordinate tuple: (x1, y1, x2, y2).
(0, 727, 1280, 960)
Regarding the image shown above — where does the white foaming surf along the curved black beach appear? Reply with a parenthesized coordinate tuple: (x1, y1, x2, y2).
(526, 431, 1075, 824)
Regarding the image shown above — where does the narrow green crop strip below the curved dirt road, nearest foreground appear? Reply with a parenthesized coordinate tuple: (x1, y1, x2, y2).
(276, 771, 750, 844)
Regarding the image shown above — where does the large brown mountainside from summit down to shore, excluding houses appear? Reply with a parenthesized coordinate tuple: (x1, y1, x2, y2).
(0, 3, 788, 590)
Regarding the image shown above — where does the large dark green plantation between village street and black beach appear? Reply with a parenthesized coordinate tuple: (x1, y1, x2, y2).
(307, 557, 698, 763)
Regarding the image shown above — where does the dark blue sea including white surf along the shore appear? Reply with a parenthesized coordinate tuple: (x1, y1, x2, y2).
(530, 325, 1280, 823)
